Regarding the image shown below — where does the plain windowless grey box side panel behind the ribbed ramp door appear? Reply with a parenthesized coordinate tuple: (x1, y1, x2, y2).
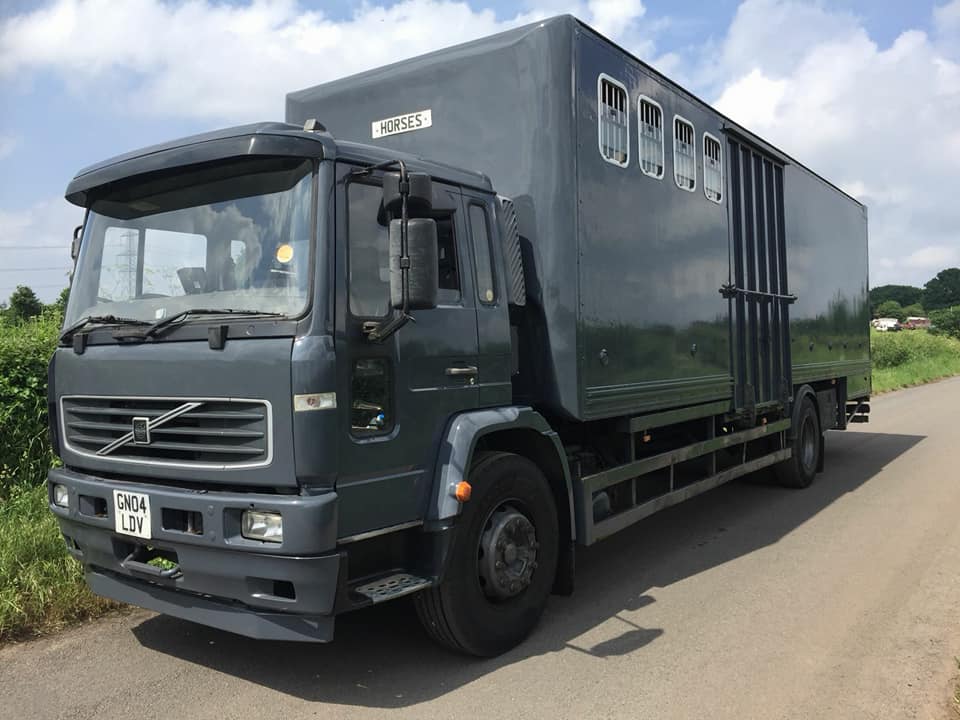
(783, 165, 870, 397)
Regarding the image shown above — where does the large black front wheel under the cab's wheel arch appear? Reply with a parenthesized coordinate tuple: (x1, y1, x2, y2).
(413, 453, 560, 657)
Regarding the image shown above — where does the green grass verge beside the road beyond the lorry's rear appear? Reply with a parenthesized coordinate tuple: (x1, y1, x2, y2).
(870, 330, 960, 393)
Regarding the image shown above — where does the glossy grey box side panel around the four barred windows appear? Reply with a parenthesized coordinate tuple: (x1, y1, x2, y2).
(576, 31, 732, 418)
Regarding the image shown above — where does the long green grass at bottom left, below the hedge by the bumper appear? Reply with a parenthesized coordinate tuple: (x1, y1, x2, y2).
(0, 485, 119, 643)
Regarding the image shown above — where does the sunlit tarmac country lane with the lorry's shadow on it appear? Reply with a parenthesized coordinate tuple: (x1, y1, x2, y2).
(0, 378, 960, 720)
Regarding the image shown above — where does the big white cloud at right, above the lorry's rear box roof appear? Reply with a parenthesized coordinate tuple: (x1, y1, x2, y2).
(706, 0, 960, 285)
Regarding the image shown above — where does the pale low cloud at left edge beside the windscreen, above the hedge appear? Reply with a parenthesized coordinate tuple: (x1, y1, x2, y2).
(0, 197, 83, 302)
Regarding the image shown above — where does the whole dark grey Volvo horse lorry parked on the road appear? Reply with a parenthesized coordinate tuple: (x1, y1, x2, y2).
(49, 16, 870, 655)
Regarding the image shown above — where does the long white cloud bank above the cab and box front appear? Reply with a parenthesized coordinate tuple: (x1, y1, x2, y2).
(0, 0, 652, 122)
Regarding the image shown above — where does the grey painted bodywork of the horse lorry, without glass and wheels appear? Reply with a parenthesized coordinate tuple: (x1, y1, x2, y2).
(50, 16, 870, 640)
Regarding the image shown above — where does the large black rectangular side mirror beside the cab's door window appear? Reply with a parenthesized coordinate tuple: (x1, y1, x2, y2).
(390, 218, 440, 310)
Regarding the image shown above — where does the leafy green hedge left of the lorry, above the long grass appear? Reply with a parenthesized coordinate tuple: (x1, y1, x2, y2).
(0, 311, 60, 500)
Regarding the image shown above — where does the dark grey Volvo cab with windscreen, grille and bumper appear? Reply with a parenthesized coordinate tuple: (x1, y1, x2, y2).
(49, 123, 564, 652)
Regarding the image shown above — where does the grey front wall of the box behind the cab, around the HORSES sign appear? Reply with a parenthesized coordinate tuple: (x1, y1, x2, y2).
(287, 18, 580, 417)
